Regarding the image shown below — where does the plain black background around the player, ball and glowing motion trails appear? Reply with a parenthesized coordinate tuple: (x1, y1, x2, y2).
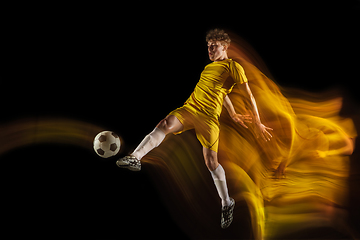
(0, 1, 360, 239)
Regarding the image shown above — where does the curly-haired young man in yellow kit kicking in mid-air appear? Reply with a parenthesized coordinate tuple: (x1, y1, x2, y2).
(116, 29, 272, 228)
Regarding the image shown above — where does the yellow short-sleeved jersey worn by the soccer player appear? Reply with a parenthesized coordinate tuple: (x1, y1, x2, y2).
(184, 59, 248, 118)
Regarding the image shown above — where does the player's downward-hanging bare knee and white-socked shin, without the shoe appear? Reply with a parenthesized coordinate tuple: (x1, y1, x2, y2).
(203, 147, 231, 207)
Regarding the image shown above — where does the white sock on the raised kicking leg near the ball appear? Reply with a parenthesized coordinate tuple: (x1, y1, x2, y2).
(130, 127, 166, 160)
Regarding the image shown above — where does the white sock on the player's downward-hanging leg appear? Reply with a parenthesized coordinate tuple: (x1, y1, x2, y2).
(210, 164, 231, 207)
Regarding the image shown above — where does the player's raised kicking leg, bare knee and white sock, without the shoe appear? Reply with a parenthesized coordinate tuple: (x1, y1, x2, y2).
(130, 115, 183, 160)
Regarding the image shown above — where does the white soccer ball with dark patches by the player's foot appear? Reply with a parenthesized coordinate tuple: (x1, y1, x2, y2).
(94, 131, 121, 158)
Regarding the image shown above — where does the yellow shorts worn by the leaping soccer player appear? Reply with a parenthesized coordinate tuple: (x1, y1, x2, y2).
(169, 105, 220, 152)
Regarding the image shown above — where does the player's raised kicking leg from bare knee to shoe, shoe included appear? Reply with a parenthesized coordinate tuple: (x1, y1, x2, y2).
(116, 115, 183, 171)
